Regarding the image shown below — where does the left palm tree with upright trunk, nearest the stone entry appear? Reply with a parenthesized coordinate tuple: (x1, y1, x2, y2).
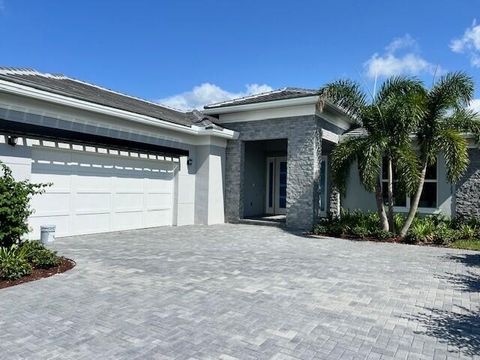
(320, 77, 423, 231)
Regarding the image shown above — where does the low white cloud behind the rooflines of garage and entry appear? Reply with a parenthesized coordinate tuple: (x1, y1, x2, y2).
(158, 83, 272, 110)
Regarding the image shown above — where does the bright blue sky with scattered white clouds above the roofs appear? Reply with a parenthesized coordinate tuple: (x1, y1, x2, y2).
(0, 0, 480, 110)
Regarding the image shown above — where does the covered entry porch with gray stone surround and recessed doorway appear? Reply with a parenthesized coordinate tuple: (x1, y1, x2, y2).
(225, 116, 340, 230)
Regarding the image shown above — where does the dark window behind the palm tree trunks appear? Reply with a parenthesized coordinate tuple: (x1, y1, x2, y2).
(382, 161, 437, 209)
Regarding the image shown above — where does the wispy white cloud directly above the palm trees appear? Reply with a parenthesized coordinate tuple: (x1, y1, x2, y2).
(363, 34, 443, 79)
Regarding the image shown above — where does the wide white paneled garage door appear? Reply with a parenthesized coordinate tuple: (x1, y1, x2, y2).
(30, 148, 177, 238)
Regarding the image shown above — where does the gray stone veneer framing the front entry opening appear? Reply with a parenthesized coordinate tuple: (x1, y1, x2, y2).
(223, 116, 322, 230)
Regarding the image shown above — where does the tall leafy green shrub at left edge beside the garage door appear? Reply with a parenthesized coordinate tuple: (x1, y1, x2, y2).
(0, 161, 48, 248)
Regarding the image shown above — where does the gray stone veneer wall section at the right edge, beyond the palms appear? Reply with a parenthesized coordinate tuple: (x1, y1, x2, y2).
(455, 149, 480, 218)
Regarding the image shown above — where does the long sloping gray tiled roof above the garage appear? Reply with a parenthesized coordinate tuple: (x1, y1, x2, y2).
(0, 67, 194, 126)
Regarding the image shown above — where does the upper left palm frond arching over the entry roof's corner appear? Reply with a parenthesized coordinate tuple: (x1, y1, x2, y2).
(319, 80, 367, 121)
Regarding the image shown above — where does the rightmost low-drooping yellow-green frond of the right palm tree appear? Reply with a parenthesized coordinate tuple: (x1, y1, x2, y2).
(435, 128, 469, 183)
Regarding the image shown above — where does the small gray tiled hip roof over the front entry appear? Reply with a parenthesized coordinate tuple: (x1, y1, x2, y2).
(205, 87, 318, 109)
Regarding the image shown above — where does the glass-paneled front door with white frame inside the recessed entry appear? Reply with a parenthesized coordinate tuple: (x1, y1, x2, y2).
(265, 157, 287, 215)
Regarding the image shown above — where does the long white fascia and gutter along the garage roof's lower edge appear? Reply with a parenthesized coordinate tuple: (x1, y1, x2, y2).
(0, 80, 238, 139)
